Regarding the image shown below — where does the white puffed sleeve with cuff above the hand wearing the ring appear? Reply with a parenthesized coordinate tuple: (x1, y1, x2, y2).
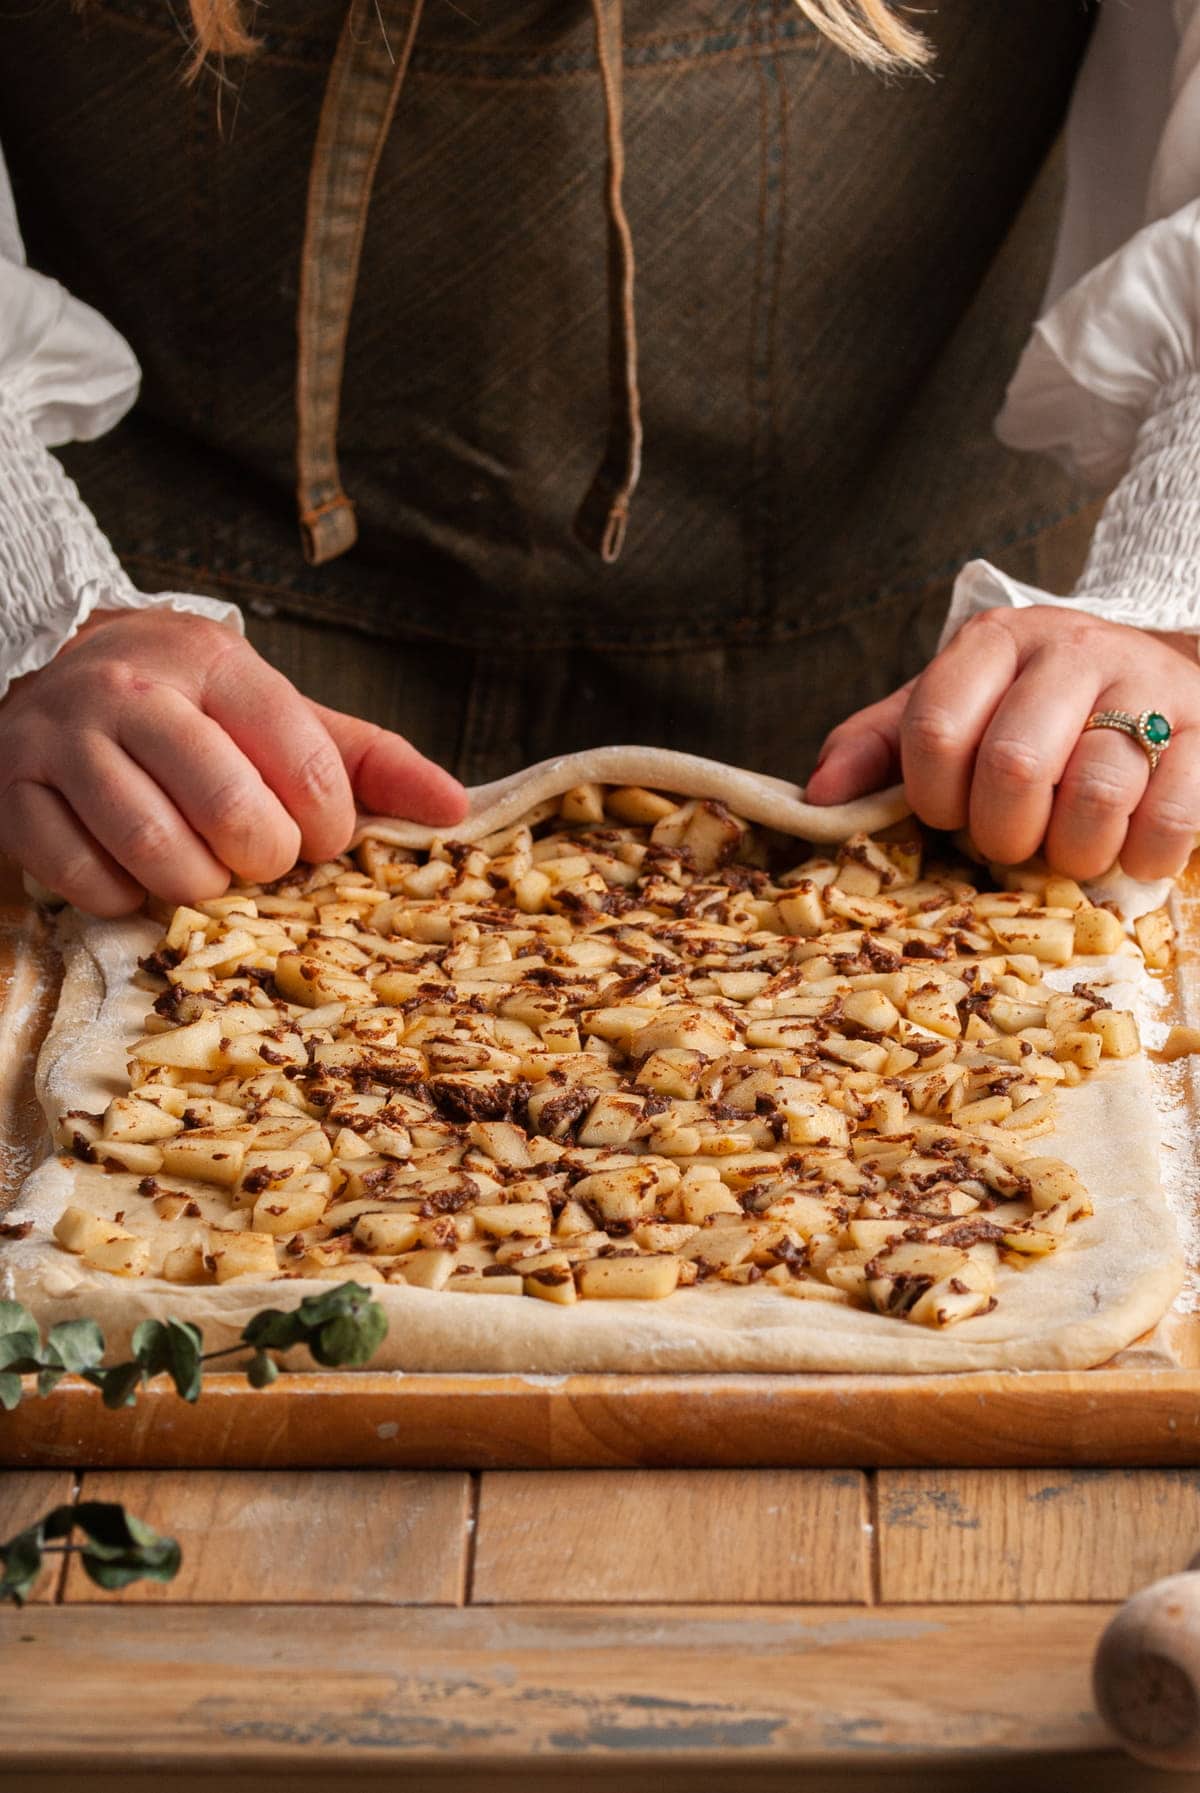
(943, 0, 1200, 642)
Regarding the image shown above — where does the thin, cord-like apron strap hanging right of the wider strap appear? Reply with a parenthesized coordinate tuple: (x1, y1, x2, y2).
(576, 0, 642, 563)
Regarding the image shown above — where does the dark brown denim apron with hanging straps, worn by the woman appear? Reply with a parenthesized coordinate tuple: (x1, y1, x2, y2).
(0, 0, 1091, 780)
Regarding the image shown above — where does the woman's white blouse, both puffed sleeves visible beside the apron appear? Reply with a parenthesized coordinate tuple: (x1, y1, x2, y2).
(0, 0, 1200, 696)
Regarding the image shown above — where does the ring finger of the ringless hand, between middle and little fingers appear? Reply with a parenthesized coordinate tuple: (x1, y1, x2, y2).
(56, 732, 230, 907)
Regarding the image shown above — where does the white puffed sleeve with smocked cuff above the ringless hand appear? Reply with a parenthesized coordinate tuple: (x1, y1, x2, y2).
(0, 141, 240, 696)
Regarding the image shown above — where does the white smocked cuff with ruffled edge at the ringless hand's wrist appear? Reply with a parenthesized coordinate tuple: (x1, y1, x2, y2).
(0, 393, 242, 697)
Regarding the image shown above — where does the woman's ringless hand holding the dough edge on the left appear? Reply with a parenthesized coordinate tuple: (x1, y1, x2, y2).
(0, 608, 466, 916)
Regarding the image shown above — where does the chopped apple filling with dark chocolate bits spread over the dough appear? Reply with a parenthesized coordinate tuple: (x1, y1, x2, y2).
(46, 785, 1162, 1327)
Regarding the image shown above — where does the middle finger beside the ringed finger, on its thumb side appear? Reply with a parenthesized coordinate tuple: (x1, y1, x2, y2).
(969, 647, 1097, 866)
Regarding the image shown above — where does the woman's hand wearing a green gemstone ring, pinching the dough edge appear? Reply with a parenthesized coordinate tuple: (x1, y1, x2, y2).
(805, 604, 1200, 879)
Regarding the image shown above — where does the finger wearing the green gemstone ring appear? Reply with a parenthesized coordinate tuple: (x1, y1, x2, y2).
(1046, 702, 1159, 879)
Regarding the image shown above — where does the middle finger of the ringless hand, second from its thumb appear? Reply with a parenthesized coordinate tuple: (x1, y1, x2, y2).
(120, 687, 300, 884)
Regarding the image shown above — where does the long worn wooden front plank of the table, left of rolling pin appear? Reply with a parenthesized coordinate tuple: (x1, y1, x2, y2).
(0, 1605, 1112, 1786)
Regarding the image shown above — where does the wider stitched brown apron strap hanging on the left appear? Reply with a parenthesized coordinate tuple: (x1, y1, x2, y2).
(296, 0, 423, 567)
